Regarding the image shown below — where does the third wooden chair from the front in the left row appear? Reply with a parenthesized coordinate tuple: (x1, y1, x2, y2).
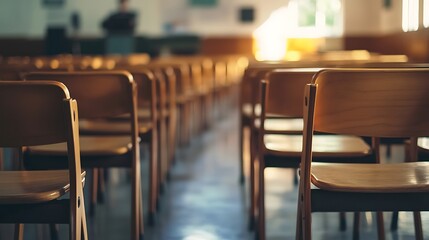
(73, 69, 159, 225)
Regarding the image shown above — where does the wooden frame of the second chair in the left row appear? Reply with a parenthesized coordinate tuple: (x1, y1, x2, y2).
(25, 71, 143, 239)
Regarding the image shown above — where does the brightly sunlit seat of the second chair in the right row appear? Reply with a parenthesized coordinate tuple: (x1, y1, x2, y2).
(264, 134, 371, 157)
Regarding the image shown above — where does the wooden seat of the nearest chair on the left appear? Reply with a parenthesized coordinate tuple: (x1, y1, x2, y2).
(0, 170, 85, 204)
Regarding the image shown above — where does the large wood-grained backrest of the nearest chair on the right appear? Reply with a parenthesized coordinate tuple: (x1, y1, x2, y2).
(307, 68, 429, 137)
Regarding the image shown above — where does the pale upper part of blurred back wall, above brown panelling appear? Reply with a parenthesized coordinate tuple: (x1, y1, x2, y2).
(0, 0, 402, 37)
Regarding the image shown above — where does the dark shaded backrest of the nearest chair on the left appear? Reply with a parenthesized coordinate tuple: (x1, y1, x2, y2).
(0, 81, 76, 147)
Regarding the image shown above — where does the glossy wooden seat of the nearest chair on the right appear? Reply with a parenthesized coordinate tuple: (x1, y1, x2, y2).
(311, 162, 429, 193)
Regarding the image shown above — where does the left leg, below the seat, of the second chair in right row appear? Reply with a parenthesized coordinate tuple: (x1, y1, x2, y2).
(257, 158, 265, 240)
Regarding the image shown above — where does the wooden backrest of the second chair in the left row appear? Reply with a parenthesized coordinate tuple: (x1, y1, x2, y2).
(25, 71, 137, 119)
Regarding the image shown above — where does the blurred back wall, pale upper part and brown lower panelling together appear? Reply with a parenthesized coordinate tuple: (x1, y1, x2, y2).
(0, 0, 429, 61)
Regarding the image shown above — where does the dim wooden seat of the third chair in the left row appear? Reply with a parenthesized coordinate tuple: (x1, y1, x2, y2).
(79, 120, 152, 135)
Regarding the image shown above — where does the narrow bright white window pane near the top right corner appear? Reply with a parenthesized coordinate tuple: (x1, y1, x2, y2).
(402, 0, 418, 32)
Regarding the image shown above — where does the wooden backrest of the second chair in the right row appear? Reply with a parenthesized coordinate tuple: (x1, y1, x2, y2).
(261, 68, 320, 118)
